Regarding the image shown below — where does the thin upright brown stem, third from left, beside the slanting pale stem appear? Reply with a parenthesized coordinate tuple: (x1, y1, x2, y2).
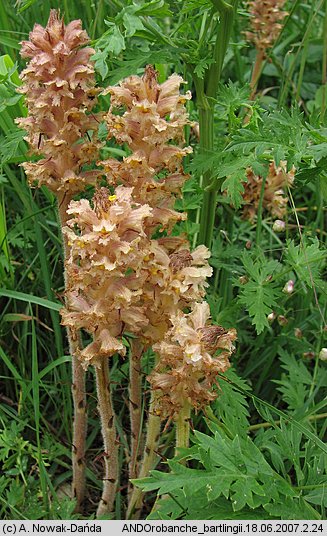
(129, 339, 143, 491)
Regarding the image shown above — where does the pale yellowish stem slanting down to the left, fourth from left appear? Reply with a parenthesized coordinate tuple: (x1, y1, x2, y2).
(127, 394, 161, 519)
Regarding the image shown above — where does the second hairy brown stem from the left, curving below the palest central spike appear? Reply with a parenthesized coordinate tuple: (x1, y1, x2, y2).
(95, 361, 119, 518)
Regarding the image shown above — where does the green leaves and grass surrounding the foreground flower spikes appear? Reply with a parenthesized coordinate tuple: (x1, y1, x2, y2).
(0, 0, 327, 520)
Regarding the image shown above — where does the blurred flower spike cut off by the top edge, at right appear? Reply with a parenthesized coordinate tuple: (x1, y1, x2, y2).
(245, 0, 287, 55)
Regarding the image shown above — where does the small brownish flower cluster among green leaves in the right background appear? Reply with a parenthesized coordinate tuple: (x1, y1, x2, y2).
(243, 161, 295, 221)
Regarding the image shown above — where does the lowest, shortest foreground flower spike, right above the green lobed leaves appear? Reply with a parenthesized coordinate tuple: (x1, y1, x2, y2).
(149, 302, 236, 418)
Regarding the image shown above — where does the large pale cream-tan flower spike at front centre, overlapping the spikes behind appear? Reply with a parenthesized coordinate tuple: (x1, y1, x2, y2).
(62, 186, 151, 368)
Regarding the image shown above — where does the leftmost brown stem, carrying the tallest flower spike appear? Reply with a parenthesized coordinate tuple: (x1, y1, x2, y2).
(58, 194, 87, 512)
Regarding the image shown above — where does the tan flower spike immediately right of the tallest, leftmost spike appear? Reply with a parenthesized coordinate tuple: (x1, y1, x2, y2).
(102, 66, 192, 231)
